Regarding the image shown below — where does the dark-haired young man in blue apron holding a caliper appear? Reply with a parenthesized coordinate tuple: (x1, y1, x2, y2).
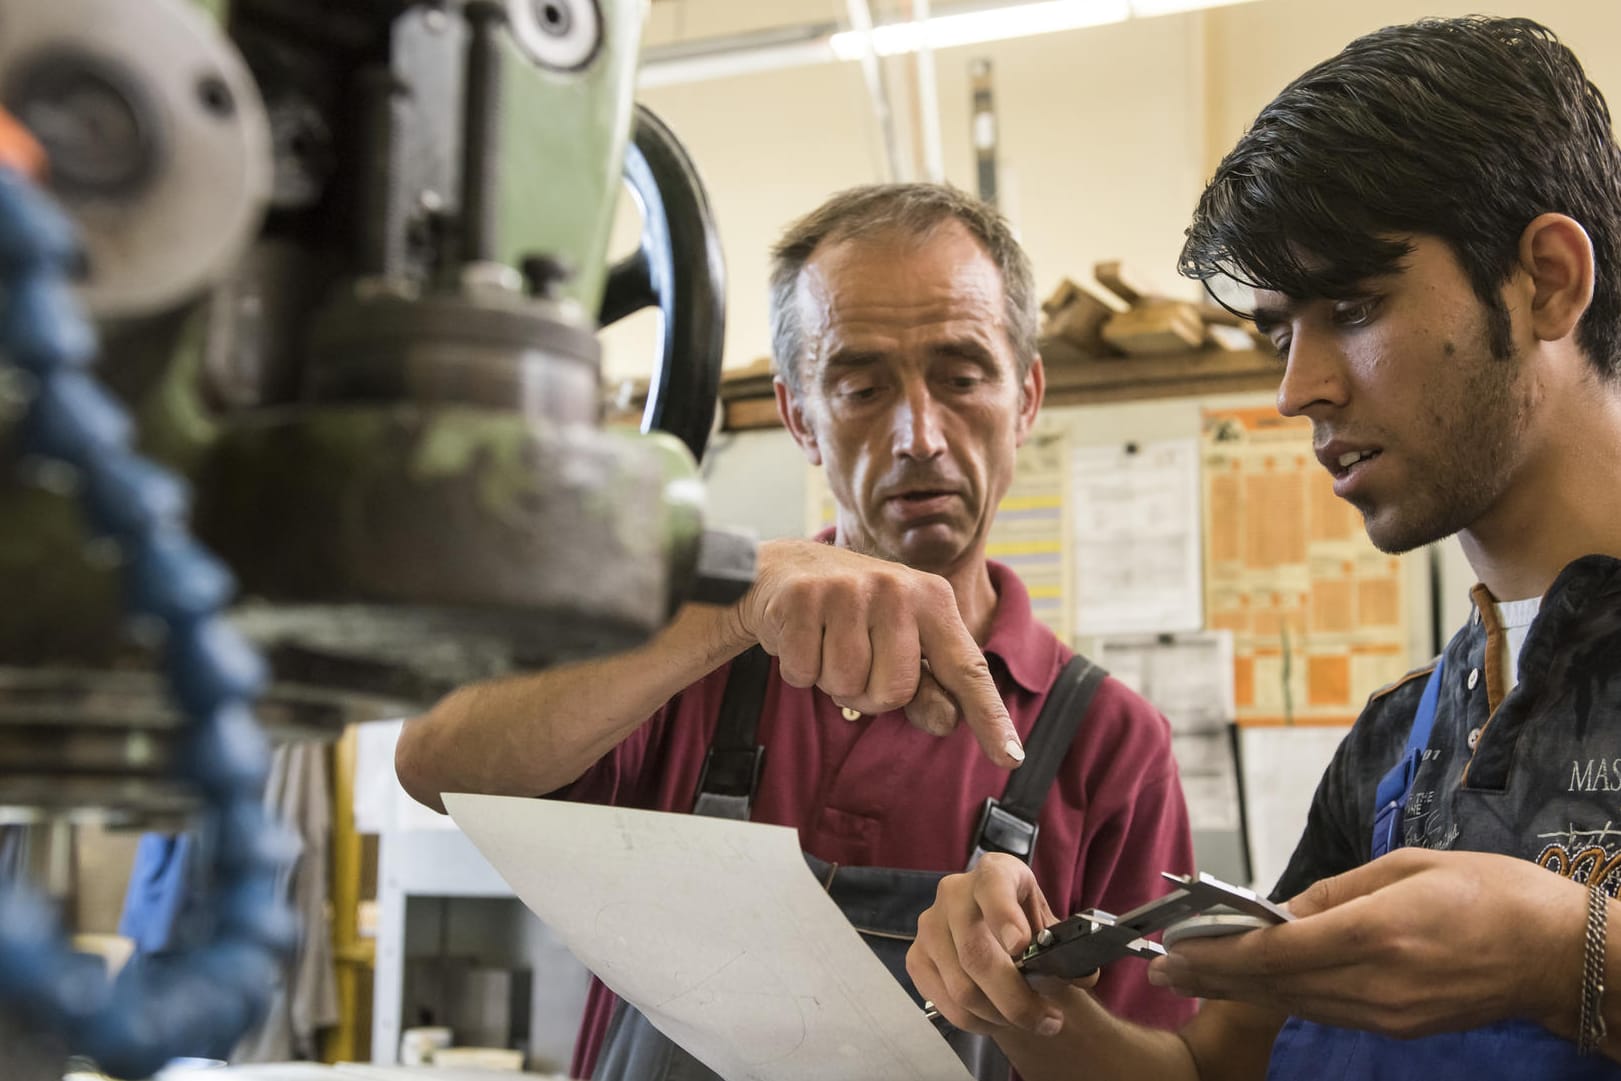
(908, 18, 1621, 1081)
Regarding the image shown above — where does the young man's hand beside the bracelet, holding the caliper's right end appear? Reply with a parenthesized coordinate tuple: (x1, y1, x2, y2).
(1149, 848, 1587, 1037)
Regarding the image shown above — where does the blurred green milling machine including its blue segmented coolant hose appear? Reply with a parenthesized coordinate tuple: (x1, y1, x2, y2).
(0, 0, 754, 1081)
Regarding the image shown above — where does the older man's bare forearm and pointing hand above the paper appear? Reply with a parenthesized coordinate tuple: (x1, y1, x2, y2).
(394, 540, 1018, 810)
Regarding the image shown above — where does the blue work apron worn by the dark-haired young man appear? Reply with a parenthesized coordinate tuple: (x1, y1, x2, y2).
(1266, 661, 1621, 1081)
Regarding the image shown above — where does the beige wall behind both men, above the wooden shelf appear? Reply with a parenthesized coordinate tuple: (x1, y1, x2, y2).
(606, 0, 1621, 387)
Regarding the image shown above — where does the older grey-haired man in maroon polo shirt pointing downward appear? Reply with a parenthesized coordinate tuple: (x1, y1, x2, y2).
(397, 185, 1191, 1081)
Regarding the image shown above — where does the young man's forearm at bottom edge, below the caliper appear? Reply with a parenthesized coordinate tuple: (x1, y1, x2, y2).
(997, 989, 1282, 1081)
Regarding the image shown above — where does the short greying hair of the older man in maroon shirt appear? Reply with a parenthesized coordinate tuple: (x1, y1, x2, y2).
(770, 183, 1037, 394)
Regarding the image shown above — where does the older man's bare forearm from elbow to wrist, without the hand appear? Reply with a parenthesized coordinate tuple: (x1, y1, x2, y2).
(394, 605, 751, 812)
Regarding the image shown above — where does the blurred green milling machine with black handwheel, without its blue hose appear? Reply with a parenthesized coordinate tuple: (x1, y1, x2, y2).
(0, 0, 754, 823)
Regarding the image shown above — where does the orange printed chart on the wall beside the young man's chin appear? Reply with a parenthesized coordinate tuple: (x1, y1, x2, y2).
(1201, 408, 1409, 726)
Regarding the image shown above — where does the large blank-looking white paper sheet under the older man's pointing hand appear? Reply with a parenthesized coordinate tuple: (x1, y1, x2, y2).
(444, 793, 969, 1081)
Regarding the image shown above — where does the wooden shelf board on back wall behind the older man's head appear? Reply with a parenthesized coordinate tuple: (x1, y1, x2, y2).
(720, 339, 1284, 431)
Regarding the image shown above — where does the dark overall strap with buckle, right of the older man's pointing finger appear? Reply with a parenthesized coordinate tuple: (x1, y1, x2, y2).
(968, 653, 1109, 867)
